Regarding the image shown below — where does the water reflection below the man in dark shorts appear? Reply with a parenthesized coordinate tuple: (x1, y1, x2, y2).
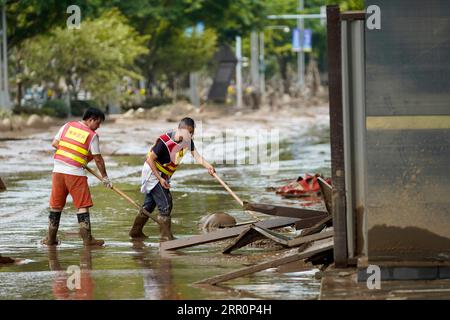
(132, 241, 183, 300)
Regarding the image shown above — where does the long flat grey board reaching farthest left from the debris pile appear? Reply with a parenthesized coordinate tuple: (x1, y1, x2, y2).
(160, 218, 299, 250)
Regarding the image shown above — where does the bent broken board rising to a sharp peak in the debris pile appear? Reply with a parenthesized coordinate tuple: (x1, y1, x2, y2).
(222, 226, 333, 254)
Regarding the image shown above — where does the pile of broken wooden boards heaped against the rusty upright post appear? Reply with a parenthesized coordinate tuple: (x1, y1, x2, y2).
(160, 177, 333, 285)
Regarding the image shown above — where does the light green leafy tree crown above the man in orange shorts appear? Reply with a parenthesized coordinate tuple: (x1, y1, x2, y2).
(21, 9, 148, 103)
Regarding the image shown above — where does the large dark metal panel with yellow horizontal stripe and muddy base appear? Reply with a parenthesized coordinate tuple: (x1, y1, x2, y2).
(366, 0, 450, 261)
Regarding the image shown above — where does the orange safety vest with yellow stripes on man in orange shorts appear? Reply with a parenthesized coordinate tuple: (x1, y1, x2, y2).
(55, 121, 96, 168)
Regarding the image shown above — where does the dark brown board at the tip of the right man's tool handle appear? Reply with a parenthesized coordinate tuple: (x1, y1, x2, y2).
(244, 201, 328, 219)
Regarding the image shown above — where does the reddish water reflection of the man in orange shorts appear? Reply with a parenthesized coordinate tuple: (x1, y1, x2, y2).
(48, 246, 95, 300)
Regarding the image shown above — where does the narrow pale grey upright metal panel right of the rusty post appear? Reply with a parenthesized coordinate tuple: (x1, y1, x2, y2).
(342, 20, 366, 258)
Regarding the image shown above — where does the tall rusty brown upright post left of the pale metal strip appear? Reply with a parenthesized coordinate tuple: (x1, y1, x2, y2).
(327, 5, 347, 268)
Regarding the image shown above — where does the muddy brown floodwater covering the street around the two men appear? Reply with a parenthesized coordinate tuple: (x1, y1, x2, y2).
(0, 109, 330, 299)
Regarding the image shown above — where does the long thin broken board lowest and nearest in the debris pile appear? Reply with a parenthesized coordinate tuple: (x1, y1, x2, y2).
(196, 239, 333, 285)
